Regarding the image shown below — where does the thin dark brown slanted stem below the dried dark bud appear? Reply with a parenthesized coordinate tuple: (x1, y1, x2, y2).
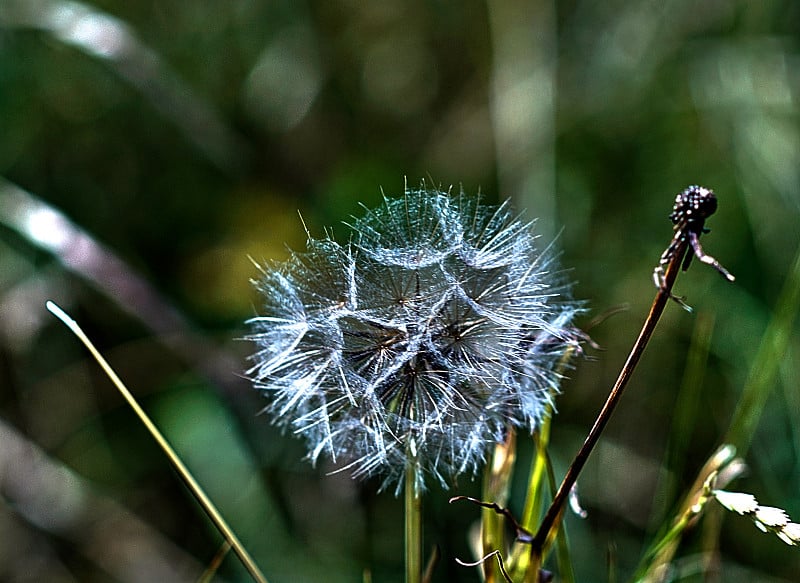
(531, 241, 689, 562)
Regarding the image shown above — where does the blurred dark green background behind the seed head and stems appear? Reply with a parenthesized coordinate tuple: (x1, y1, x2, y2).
(0, 0, 800, 583)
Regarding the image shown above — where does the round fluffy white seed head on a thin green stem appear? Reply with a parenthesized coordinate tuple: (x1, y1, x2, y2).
(248, 185, 580, 492)
